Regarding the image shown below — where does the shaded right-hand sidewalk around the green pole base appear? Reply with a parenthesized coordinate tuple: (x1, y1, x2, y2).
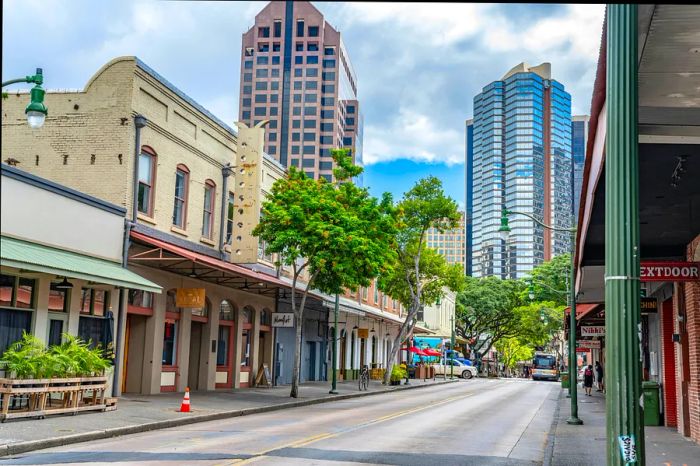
(544, 387, 700, 466)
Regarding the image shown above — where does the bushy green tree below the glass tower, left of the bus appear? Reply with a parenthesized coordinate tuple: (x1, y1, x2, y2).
(455, 277, 525, 357)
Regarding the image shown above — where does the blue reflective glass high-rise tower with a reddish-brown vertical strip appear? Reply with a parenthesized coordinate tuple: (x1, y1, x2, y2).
(467, 63, 572, 278)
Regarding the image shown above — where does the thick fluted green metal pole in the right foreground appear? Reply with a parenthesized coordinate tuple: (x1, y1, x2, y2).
(605, 4, 645, 466)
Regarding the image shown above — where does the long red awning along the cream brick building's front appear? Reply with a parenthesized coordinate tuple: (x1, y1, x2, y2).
(129, 231, 290, 294)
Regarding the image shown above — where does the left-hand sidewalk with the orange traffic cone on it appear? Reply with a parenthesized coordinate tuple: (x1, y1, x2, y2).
(0, 379, 451, 456)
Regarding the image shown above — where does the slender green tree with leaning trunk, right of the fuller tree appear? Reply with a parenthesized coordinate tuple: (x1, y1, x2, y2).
(379, 176, 464, 385)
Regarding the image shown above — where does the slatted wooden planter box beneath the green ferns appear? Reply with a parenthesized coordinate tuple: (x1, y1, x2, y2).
(0, 376, 107, 422)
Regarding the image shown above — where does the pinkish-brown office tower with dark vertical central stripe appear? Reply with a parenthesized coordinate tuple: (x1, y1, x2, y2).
(239, 1, 362, 181)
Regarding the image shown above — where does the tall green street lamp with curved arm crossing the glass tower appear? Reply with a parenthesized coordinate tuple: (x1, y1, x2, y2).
(498, 209, 583, 425)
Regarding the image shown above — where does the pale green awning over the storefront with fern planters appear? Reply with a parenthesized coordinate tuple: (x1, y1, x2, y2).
(0, 236, 162, 293)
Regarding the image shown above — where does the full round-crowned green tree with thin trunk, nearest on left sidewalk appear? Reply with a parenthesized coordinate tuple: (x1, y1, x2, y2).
(253, 150, 396, 398)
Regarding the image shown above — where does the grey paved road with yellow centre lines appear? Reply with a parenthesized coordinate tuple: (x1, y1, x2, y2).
(0, 379, 559, 466)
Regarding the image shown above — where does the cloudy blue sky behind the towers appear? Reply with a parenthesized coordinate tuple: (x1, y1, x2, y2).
(2, 0, 604, 206)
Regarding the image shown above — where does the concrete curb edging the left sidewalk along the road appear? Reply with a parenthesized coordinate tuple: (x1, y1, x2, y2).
(0, 379, 459, 457)
